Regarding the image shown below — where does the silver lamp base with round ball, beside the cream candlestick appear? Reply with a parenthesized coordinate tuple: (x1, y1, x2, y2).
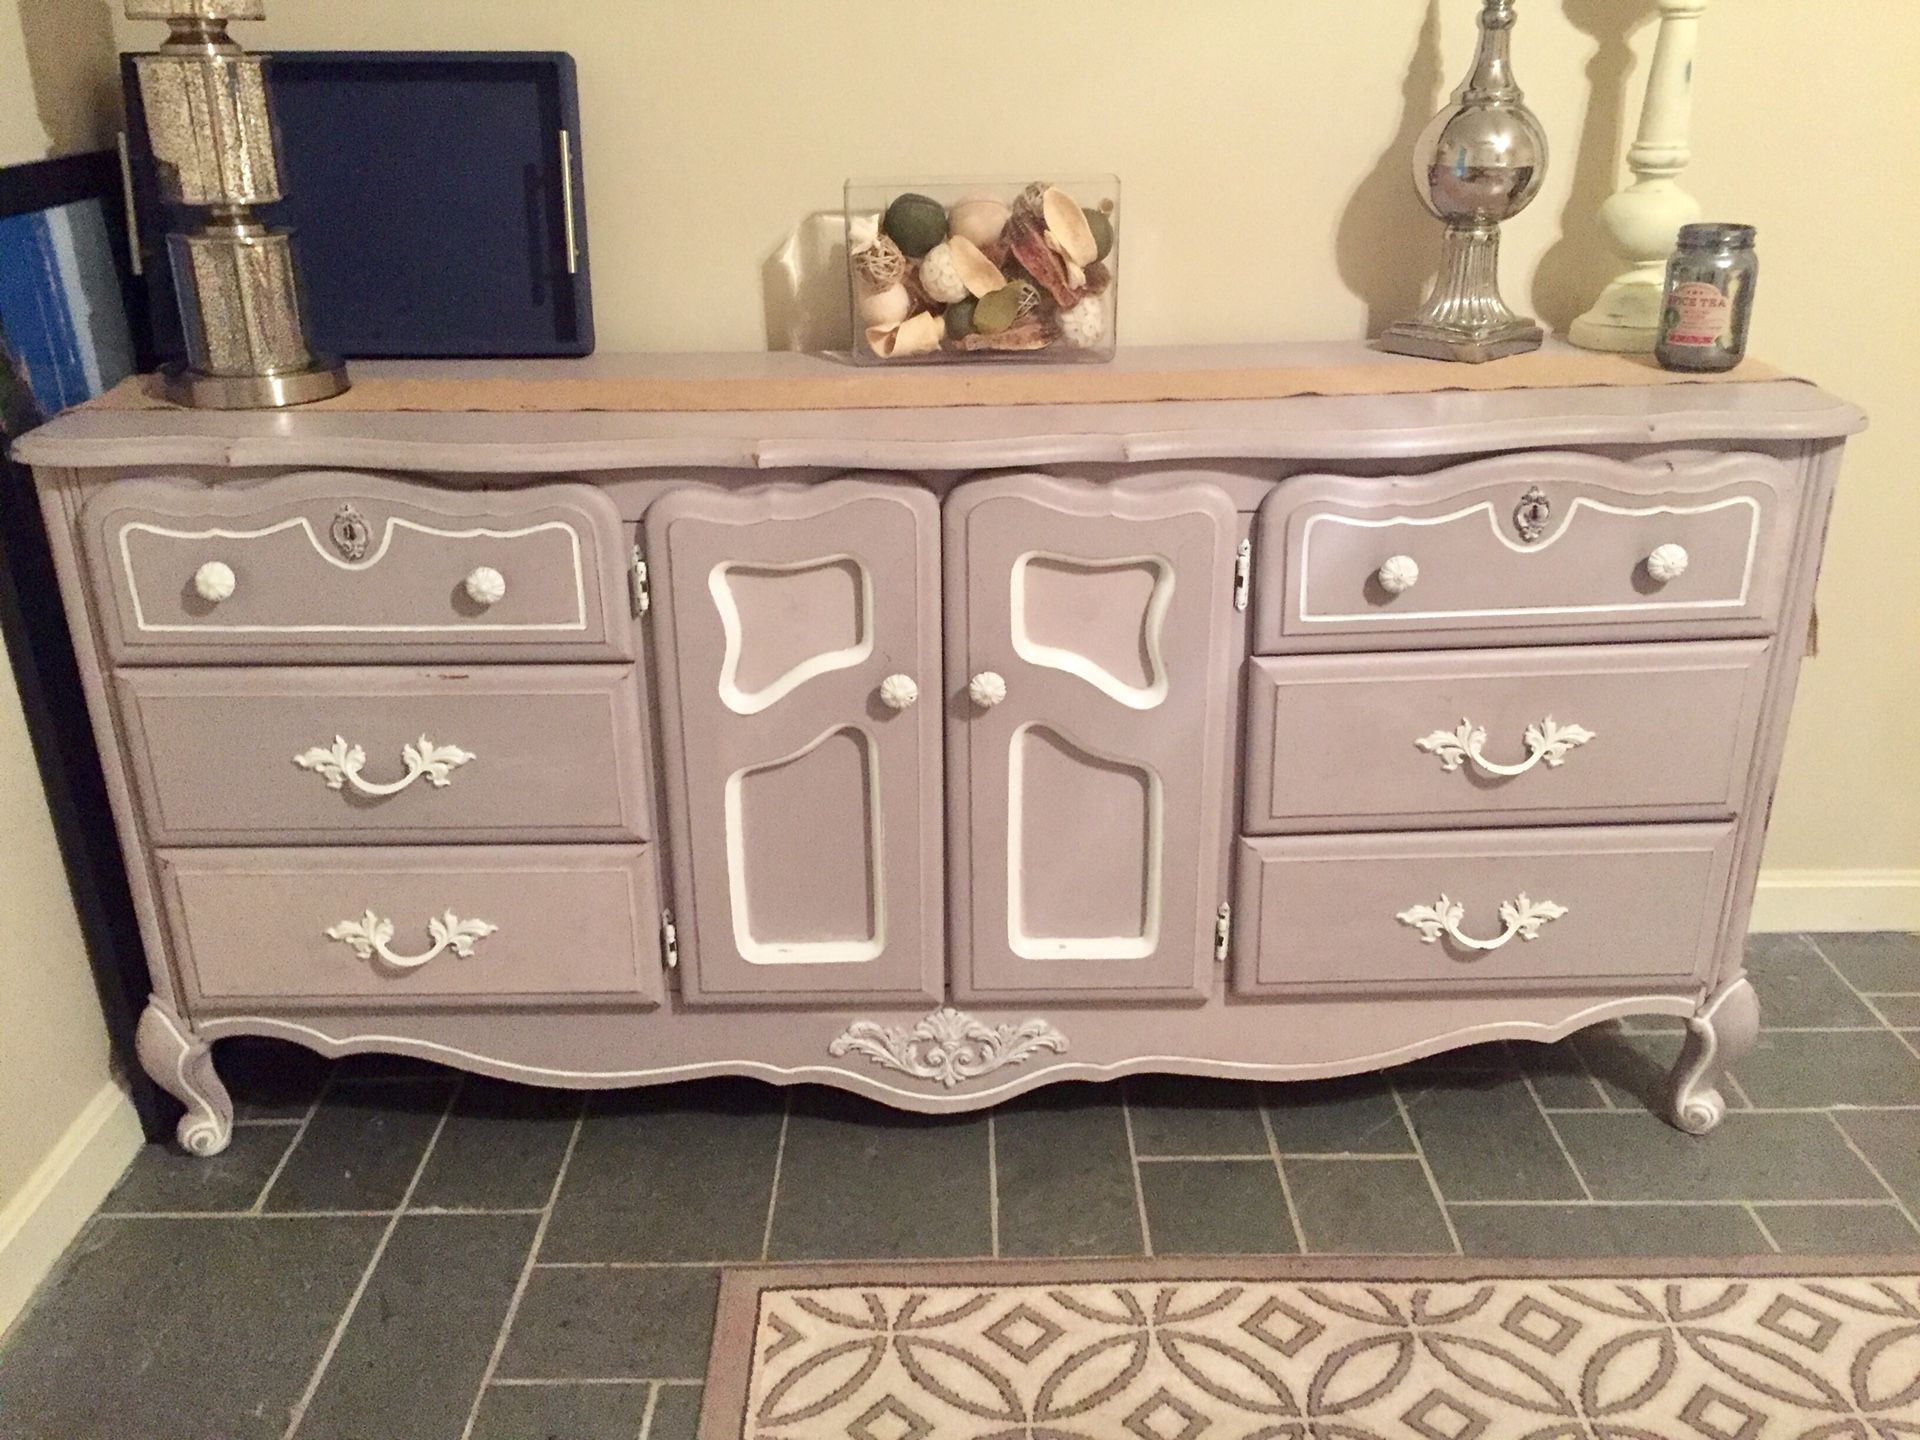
(1380, 0, 1548, 365)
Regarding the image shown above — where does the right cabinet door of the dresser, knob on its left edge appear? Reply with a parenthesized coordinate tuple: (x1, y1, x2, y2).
(947, 476, 1238, 1000)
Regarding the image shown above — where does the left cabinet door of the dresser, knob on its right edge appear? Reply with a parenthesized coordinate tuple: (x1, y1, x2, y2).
(645, 480, 941, 1004)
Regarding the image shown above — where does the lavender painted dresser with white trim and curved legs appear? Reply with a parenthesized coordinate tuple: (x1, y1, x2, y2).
(21, 348, 1862, 1154)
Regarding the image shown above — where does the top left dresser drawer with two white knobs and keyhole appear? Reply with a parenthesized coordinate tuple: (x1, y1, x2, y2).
(81, 472, 634, 664)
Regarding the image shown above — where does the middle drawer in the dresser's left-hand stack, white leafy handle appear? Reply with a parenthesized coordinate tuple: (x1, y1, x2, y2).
(117, 664, 649, 845)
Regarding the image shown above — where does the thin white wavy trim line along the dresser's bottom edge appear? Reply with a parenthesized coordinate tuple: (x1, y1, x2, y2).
(200, 995, 1695, 1110)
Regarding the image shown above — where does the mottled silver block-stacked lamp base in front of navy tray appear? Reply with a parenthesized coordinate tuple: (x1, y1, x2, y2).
(127, 0, 348, 409)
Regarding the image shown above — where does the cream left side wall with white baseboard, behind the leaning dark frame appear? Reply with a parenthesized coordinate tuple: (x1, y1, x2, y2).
(0, 0, 140, 1331)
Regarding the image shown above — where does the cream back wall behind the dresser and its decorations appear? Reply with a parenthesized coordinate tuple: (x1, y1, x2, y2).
(105, 0, 1920, 906)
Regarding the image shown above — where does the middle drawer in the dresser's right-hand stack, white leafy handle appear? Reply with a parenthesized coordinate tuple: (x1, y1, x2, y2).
(1242, 639, 1768, 835)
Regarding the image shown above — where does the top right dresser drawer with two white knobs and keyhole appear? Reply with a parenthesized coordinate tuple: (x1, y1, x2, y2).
(1254, 453, 1799, 651)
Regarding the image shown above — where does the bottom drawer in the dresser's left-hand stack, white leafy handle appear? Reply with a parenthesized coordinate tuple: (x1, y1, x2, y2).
(159, 845, 660, 1012)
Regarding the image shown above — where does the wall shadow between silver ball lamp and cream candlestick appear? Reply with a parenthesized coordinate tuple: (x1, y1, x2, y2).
(1532, 0, 1653, 332)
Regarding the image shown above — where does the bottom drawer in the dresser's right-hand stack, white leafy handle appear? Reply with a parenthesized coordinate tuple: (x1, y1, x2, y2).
(1233, 826, 1734, 995)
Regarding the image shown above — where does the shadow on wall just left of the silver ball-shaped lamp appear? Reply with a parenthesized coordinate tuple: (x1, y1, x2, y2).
(1336, 0, 1446, 336)
